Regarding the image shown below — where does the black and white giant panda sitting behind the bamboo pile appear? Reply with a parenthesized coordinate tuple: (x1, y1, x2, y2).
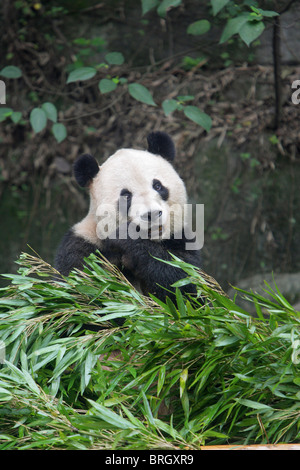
(55, 132, 201, 301)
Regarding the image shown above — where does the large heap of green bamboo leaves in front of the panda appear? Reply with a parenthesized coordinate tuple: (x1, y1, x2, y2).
(0, 254, 300, 449)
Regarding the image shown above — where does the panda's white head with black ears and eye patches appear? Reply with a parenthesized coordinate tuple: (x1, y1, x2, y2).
(74, 132, 187, 240)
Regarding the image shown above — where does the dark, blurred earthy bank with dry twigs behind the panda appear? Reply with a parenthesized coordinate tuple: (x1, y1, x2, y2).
(0, 0, 300, 302)
